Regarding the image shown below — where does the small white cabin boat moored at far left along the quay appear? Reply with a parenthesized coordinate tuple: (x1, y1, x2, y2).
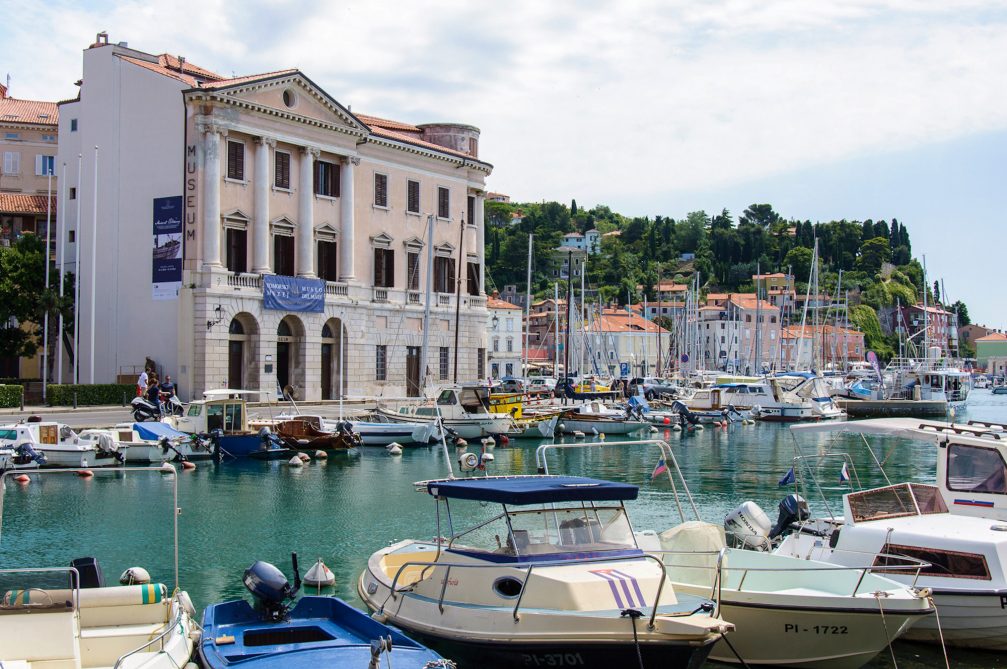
(0, 416, 128, 467)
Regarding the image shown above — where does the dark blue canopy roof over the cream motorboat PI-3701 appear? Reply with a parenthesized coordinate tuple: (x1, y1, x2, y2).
(427, 477, 638, 505)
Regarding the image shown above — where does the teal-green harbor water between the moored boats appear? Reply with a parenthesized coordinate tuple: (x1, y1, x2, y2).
(0, 390, 1007, 669)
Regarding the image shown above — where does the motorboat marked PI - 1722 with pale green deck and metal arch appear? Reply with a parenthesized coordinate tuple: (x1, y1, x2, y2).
(536, 439, 933, 669)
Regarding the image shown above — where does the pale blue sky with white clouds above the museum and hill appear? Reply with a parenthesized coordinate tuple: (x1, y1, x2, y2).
(0, 0, 1007, 327)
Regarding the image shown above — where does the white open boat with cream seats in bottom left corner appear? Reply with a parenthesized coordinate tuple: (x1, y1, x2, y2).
(0, 467, 196, 669)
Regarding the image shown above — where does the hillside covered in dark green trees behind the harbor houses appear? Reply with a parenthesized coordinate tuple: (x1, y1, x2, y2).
(485, 200, 968, 357)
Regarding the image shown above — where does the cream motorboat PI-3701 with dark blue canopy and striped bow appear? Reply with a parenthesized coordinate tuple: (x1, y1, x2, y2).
(357, 476, 732, 669)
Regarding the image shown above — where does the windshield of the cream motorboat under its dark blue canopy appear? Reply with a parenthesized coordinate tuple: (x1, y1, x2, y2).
(452, 506, 636, 557)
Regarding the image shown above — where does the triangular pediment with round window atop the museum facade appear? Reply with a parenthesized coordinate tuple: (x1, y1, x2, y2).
(185, 70, 370, 136)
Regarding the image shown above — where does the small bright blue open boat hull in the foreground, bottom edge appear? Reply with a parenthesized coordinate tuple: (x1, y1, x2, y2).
(199, 596, 440, 669)
